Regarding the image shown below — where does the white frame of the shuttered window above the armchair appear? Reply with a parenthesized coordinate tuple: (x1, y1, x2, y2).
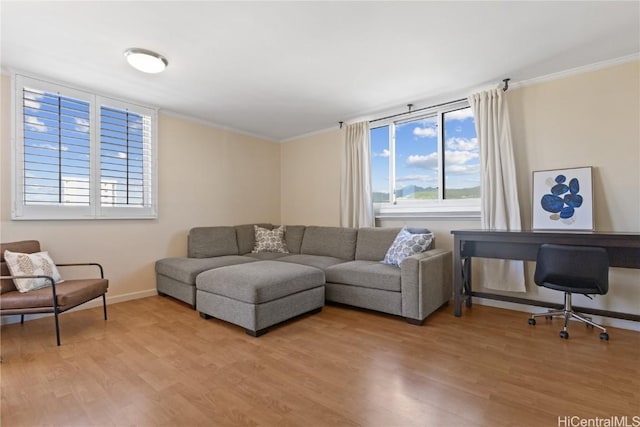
(11, 73, 158, 220)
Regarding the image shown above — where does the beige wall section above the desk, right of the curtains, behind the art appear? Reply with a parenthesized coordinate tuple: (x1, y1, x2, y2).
(507, 61, 640, 232)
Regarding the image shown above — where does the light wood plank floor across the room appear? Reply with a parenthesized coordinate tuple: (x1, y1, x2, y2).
(0, 297, 640, 427)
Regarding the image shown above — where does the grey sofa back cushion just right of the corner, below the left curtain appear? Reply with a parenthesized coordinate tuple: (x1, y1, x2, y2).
(300, 226, 358, 261)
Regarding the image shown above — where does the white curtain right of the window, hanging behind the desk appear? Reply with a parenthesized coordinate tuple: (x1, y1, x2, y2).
(469, 89, 526, 292)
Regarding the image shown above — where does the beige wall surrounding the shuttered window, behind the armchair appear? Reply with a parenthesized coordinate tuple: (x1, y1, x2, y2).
(0, 76, 280, 308)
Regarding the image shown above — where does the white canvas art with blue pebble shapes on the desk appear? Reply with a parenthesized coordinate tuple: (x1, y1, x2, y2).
(532, 167, 593, 230)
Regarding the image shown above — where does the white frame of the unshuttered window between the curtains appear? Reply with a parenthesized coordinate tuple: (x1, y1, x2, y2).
(370, 100, 481, 219)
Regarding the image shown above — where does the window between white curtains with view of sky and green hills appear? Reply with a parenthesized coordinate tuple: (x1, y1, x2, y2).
(370, 101, 480, 215)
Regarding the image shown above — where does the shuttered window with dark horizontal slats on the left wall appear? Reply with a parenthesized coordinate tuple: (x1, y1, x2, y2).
(12, 75, 157, 219)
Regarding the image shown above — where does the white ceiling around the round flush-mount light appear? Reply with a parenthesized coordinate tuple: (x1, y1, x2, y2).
(0, 0, 640, 141)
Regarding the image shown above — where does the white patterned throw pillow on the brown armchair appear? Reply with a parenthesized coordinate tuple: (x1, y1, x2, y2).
(4, 251, 63, 292)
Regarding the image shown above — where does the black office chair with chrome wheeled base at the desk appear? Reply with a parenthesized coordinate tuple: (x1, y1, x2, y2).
(529, 244, 609, 341)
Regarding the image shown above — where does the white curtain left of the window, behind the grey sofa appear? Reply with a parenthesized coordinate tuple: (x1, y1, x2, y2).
(340, 122, 374, 228)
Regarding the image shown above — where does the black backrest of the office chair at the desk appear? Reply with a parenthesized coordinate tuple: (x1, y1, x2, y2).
(534, 244, 609, 294)
